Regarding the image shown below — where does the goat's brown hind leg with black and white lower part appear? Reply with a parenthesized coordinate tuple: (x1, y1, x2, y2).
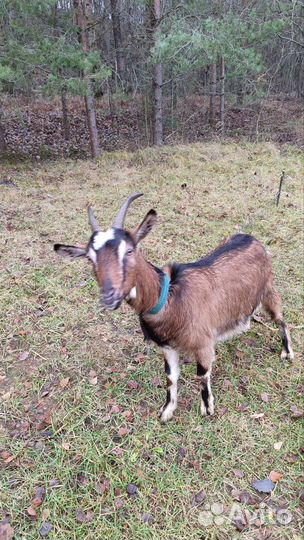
(262, 285, 294, 360)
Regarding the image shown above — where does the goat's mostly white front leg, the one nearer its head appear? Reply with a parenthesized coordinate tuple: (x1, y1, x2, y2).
(160, 347, 179, 422)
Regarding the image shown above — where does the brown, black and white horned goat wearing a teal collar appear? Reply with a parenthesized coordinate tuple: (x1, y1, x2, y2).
(54, 194, 293, 422)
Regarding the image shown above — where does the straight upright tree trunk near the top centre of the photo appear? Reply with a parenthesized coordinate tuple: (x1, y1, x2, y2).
(150, 0, 163, 146)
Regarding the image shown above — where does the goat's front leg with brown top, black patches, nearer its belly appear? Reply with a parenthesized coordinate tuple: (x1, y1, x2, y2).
(195, 345, 215, 416)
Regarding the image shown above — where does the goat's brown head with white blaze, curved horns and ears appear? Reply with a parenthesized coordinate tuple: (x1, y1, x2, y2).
(54, 193, 156, 310)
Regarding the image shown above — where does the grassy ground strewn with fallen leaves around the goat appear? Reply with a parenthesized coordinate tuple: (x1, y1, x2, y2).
(0, 143, 303, 540)
